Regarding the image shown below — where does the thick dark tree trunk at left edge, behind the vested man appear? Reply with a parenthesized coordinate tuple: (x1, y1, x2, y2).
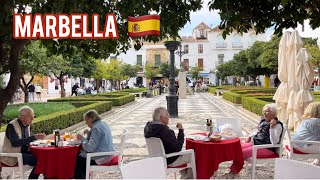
(0, 39, 30, 125)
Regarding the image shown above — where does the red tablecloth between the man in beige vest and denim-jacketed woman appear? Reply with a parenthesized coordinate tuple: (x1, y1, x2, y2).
(30, 146, 80, 179)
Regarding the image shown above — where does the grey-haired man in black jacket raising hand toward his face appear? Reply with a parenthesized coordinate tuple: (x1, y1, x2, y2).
(144, 107, 193, 178)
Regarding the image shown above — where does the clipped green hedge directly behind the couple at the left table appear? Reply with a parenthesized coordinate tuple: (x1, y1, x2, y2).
(0, 101, 112, 134)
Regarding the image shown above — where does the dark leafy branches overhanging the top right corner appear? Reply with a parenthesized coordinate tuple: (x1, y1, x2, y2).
(208, 0, 320, 37)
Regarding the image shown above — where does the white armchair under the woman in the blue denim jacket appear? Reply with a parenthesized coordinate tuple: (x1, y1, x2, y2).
(86, 129, 128, 179)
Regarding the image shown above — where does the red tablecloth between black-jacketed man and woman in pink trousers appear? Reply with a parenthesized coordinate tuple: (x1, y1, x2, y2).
(186, 138, 244, 179)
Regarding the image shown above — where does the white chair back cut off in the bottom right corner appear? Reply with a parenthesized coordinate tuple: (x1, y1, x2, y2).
(274, 158, 320, 179)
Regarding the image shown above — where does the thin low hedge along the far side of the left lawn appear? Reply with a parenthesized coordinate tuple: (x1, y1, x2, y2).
(48, 94, 135, 106)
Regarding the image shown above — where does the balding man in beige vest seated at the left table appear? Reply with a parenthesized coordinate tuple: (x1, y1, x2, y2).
(1, 106, 46, 179)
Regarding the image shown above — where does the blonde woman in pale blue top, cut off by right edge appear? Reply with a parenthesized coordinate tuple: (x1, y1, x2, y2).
(292, 102, 320, 165)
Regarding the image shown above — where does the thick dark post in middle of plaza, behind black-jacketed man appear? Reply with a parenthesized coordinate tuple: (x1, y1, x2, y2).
(164, 40, 180, 117)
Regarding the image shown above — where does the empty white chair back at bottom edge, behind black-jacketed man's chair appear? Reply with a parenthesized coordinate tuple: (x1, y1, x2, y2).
(120, 157, 166, 179)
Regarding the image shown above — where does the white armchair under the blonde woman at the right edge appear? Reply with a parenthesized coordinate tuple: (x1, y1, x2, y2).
(285, 126, 320, 159)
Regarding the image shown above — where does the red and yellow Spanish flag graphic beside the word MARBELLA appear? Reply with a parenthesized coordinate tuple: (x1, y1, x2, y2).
(128, 15, 160, 37)
